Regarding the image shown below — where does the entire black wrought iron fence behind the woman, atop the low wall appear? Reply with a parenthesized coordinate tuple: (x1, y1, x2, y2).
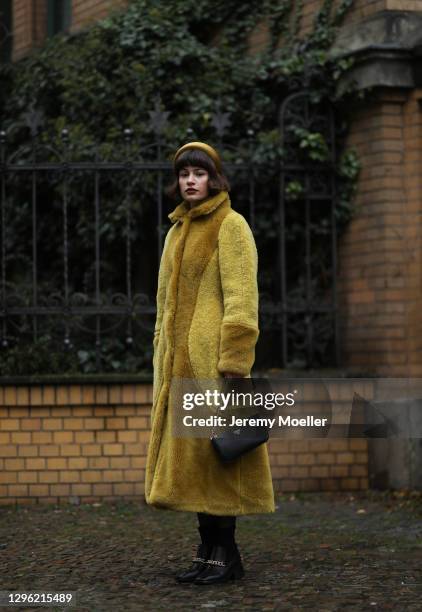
(0, 92, 338, 371)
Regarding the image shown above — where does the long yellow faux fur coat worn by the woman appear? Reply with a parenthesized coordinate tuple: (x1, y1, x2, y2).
(145, 191, 274, 516)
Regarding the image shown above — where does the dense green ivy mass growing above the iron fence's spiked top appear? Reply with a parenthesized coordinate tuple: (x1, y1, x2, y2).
(2, 0, 360, 153)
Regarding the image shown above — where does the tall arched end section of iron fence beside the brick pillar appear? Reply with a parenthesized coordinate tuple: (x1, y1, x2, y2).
(278, 91, 340, 366)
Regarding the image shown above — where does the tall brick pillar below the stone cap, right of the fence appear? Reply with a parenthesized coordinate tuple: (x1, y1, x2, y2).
(339, 90, 422, 376)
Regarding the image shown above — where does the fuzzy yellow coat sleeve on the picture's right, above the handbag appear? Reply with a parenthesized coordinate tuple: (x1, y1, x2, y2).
(217, 212, 259, 377)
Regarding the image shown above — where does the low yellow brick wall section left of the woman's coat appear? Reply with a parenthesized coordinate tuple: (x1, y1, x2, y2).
(0, 385, 151, 504)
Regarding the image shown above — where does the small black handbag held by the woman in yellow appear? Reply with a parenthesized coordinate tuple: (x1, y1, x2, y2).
(211, 414, 269, 463)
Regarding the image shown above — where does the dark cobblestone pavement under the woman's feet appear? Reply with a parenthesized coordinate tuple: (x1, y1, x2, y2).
(0, 492, 422, 612)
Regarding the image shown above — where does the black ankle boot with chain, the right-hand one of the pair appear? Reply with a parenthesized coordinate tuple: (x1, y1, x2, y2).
(194, 527, 245, 584)
